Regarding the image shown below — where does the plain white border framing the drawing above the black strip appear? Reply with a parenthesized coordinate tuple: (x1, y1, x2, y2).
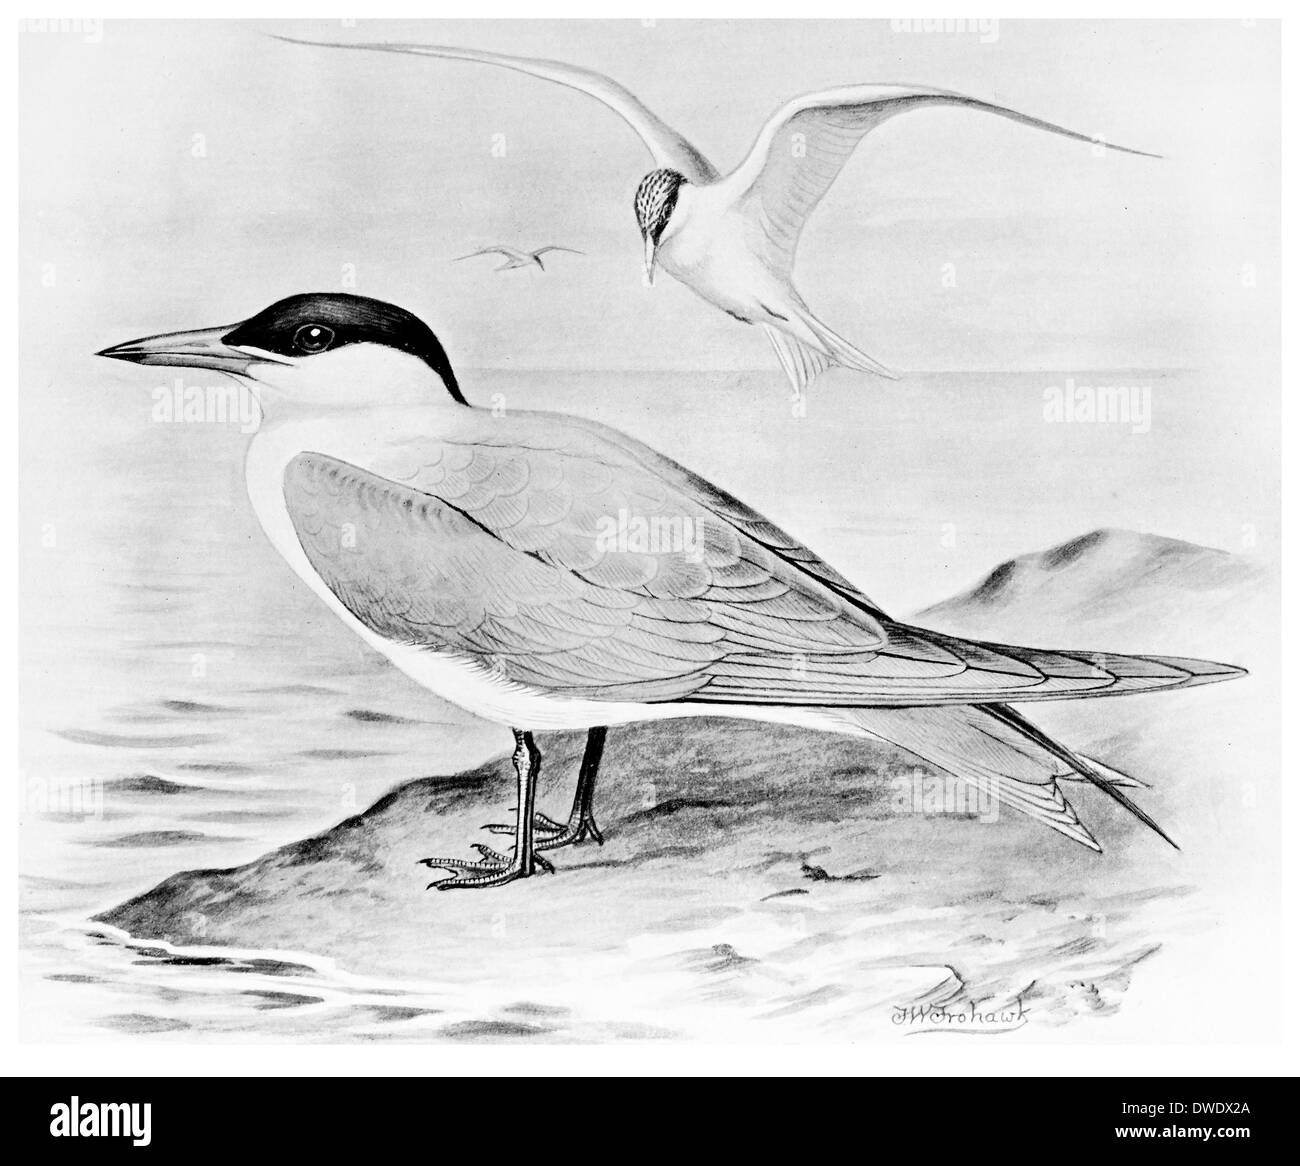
(0, 0, 1300, 1076)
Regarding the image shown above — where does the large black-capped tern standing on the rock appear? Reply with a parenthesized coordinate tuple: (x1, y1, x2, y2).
(99, 294, 1243, 889)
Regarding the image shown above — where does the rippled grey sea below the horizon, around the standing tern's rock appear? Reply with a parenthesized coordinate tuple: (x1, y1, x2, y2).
(20, 356, 1274, 1040)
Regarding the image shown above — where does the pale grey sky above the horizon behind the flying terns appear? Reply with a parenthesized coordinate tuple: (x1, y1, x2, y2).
(21, 21, 1279, 372)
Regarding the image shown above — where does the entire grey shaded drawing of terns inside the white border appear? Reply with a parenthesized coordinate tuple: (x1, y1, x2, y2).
(18, 19, 1283, 1039)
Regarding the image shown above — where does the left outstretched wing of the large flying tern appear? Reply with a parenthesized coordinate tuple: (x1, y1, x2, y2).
(276, 36, 718, 182)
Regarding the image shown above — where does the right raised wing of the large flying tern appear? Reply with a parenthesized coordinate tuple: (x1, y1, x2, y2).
(723, 84, 1158, 272)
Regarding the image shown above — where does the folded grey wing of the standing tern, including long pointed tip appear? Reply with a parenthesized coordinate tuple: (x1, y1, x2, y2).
(276, 439, 1223, 707)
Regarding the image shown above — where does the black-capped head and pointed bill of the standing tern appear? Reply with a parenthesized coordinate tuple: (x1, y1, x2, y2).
(98, 292, 465, 413)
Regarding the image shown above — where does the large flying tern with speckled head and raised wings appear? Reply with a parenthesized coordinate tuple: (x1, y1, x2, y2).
(277, 36, 1158, 396)
